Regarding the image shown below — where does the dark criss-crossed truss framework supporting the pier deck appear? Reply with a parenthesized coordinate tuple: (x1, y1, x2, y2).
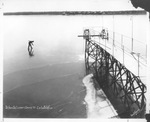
(84, 30, 146, 117)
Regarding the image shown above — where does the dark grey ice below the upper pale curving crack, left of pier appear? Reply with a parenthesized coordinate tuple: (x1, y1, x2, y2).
(3, 63, 86, 118)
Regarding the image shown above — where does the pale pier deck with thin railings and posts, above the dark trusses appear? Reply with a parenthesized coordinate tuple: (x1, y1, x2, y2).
(82, 27, 147, 78)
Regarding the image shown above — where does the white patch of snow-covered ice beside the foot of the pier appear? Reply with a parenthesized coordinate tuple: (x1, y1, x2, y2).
(83, 74, 117, 118)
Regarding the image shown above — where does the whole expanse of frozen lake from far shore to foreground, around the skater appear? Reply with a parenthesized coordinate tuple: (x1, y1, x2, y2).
(3, 15, 146, 118)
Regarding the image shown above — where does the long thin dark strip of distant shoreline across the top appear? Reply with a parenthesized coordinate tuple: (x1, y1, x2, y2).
(3, 10, 146, 15)
